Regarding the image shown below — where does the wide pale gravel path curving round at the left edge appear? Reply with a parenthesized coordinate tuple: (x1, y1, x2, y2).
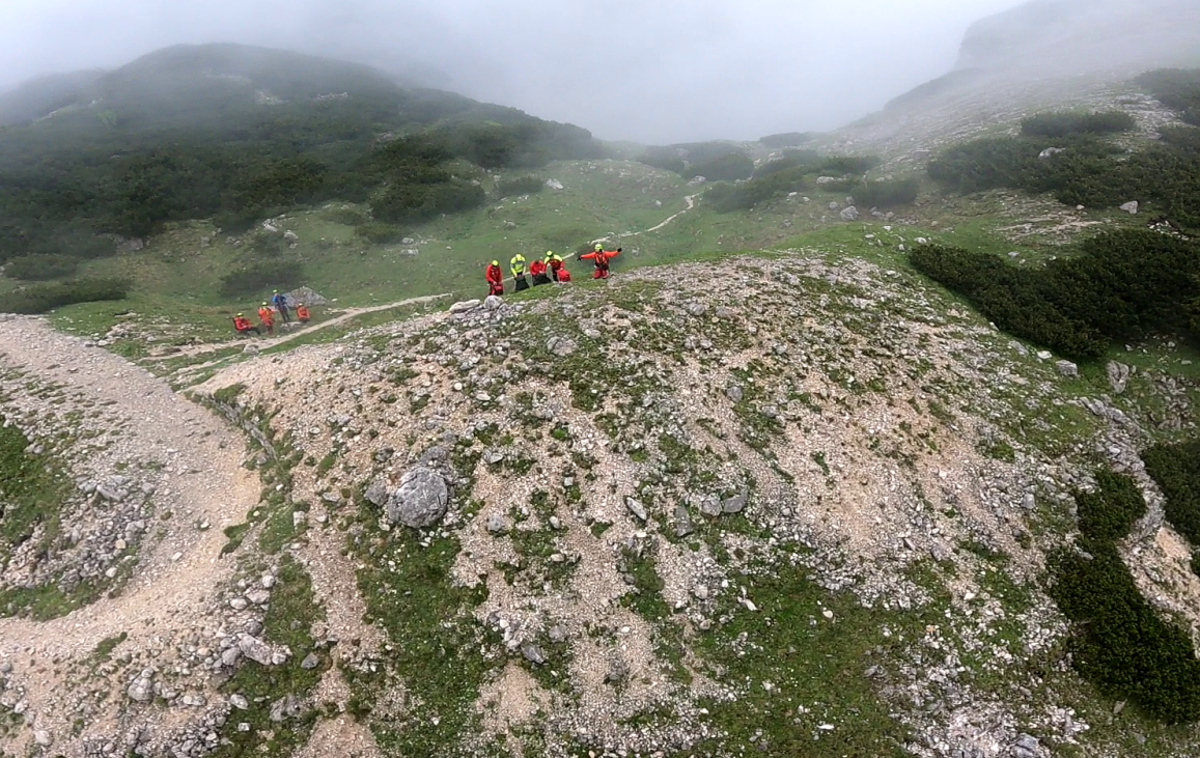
(0, 318, 260, 748)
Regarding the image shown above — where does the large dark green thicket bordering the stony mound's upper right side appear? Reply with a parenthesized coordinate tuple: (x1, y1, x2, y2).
(910, 229, 1200, 359)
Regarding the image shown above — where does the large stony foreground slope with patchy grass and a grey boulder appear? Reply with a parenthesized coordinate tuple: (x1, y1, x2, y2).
(0, 245, 1200, 758)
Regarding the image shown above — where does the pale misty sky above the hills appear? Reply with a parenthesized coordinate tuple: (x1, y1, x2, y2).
(0, 0, 1020, 143)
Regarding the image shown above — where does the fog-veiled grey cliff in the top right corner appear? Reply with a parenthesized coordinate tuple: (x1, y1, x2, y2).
(958, 0, 1200, 77)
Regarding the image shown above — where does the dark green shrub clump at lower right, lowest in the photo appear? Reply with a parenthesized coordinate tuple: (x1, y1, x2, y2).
(1050, 471, 1200, 723)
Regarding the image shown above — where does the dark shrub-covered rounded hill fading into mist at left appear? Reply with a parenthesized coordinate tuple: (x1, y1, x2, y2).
(0, 44, 602, 292)
